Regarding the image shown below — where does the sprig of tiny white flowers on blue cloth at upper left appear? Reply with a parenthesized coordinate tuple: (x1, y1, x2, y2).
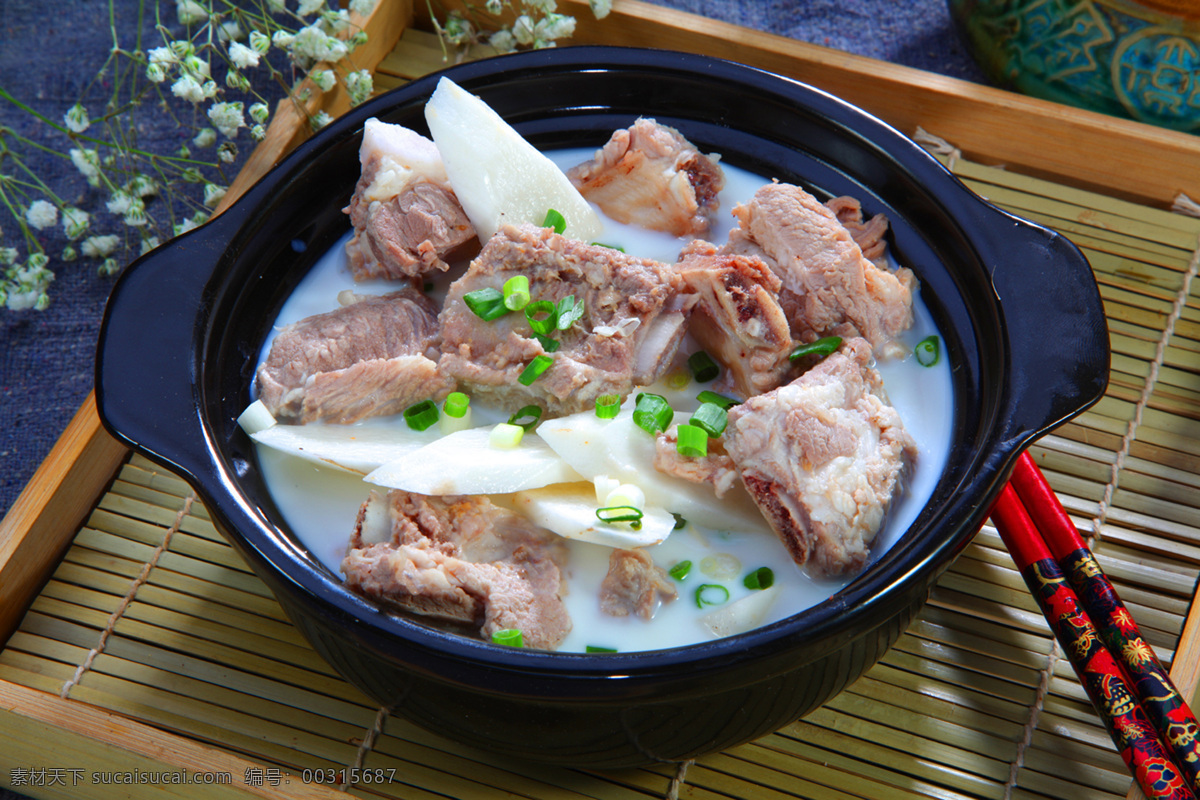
(0, 0, 376, 311)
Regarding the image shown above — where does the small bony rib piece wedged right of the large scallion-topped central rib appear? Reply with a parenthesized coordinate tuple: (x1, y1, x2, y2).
(676, 241, 792, 397)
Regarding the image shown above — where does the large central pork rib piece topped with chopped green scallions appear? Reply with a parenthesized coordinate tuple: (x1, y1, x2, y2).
(438, 225, 691, 415)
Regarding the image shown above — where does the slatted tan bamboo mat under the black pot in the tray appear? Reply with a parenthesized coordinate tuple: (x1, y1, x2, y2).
(0, 146, 1200, 800)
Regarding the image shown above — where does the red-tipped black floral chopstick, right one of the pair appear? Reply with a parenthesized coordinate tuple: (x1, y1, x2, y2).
(1009, 452, 1200, 793)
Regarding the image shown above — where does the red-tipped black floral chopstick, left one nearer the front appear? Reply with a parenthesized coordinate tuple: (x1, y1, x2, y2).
(991, 483, 1196, 800)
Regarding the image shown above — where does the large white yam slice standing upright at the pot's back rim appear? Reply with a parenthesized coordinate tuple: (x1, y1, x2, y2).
(425, 78, 604, 241)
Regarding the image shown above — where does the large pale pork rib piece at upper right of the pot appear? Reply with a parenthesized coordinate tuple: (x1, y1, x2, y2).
(724, 184, 917, 357)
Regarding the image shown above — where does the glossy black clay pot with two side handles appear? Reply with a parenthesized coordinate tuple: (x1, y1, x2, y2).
(96, 47, 1109, 768)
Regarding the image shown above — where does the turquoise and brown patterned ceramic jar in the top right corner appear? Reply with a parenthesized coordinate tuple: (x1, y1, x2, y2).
(948, 0, 1200, 132)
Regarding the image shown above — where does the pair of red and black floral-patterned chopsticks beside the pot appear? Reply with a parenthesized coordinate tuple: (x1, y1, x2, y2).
(991, 453, 1200, 800)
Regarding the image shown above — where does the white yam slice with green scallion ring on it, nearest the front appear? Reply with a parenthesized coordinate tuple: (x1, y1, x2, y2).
(512, 483, 674, 548)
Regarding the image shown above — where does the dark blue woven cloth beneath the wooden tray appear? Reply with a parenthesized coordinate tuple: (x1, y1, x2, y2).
(0, 0, 984, 800)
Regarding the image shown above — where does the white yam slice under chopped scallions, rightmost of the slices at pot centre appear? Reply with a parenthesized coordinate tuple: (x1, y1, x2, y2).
(538, 403, 770, 533)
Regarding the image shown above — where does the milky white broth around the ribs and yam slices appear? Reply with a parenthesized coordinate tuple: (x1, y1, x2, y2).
(258, 149, 953, 651)
